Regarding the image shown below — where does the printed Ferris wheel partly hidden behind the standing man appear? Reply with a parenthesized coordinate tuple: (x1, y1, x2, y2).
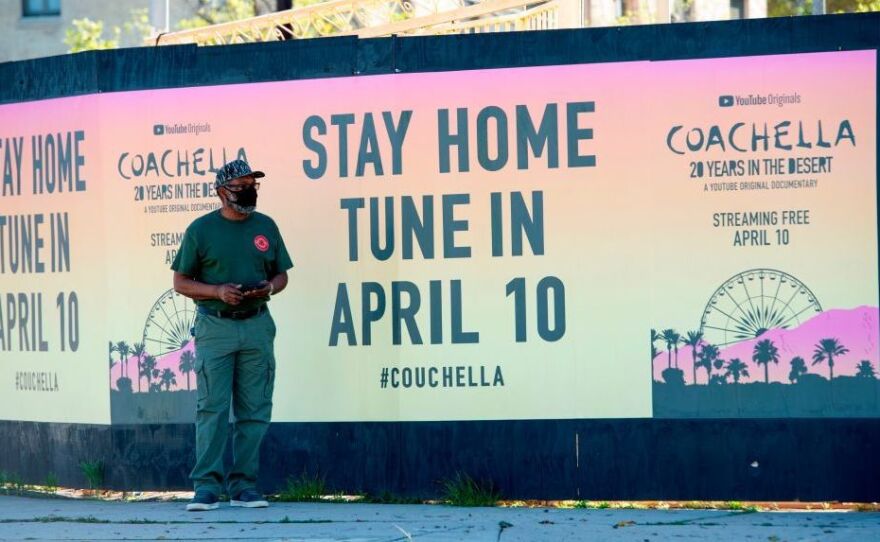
(144, 290, 196, 355)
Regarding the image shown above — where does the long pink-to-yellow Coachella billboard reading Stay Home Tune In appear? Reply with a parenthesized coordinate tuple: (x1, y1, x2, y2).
(0, 51, 880, 423)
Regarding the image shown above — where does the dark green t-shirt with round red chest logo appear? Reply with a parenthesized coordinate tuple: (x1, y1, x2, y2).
(171, 210, 293, 311)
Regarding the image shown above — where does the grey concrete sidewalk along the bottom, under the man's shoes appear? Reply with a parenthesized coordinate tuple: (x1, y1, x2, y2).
(0, 496, 880, 542)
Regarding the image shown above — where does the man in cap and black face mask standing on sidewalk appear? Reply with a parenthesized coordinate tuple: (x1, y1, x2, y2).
(171, 160, 293, 511)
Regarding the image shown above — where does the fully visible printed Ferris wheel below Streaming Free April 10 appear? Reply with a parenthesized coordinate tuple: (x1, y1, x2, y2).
(700, 269, 822, 346)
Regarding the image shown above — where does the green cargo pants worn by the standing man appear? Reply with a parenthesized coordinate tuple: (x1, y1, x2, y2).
(190, 310, 275, 497)
